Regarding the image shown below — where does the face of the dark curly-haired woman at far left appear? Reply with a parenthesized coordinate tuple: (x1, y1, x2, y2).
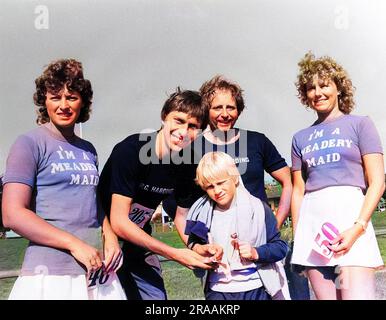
(45, 87, 83, 129)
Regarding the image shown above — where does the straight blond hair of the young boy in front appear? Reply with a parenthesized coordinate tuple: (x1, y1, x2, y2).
(195, 151, 240, 190)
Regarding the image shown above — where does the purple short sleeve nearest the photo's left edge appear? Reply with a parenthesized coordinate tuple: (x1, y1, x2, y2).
(3, 135, 39, 188)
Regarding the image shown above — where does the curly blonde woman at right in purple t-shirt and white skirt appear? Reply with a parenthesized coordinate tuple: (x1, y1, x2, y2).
(291, 53, 385, 299)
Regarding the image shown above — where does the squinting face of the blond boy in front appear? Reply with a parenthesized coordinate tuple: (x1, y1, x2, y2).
(205, 176, 237, 210)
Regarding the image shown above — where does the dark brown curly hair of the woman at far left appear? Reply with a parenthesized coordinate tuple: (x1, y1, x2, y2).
(33, 59, 93, 125)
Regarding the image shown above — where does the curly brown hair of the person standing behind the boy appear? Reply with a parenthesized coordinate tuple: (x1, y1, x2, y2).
(200, 75, 245, 115)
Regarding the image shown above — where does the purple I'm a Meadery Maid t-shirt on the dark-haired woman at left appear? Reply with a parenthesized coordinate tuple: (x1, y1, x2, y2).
(3, 125, 101, 275)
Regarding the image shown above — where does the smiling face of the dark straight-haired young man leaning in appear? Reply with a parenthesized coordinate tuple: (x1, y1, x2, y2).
(162, 111, 201, 152)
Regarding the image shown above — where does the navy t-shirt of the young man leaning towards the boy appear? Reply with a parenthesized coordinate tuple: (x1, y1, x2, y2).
(98, 132, 174, 251)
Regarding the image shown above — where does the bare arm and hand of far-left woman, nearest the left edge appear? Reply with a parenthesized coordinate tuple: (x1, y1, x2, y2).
(2, 183, 102, 271)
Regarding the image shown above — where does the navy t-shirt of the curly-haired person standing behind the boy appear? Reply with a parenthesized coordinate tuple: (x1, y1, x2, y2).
(173, 129, 287, 208)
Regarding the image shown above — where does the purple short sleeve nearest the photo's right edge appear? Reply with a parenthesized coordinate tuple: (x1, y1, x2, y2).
(358, 117, 383, 155)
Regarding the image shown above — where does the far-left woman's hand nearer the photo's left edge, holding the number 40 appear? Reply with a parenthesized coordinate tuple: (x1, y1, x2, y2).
(69, 239, 102, 273)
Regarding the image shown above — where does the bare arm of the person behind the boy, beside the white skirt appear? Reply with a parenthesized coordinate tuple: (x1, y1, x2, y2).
(271, 166, 292, 229)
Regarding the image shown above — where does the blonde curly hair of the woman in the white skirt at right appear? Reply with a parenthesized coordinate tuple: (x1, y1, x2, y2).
(295, 52, 355, 114)
